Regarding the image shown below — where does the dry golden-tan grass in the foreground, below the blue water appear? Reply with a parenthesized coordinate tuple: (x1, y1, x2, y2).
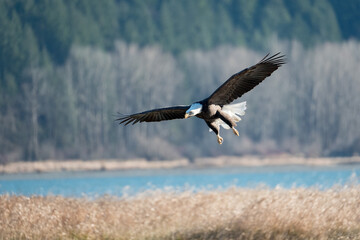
(0, 185, 360, 239)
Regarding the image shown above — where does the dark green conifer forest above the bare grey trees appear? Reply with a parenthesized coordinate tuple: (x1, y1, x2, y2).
(0, 0, 360, 78)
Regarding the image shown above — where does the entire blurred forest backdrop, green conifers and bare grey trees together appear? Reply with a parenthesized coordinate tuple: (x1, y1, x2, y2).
(0, 0, 360, 163)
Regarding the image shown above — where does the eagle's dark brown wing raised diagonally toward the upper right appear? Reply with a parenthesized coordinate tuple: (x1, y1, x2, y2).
(208, 53, 285, 106)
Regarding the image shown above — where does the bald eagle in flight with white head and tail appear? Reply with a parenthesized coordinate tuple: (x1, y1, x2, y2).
(116, 53, 285, 144)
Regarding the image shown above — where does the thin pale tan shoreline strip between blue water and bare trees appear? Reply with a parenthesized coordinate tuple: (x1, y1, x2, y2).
(0, 155, 360, 175)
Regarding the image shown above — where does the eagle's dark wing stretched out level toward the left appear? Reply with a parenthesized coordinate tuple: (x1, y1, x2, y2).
(116, 106, 190, 126)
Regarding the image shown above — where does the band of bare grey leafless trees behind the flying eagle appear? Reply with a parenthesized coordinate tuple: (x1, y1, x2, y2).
(1, 41, 360, 159)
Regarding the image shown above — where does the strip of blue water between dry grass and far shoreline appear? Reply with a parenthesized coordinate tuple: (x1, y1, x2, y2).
(0, 165, 360, 197)
